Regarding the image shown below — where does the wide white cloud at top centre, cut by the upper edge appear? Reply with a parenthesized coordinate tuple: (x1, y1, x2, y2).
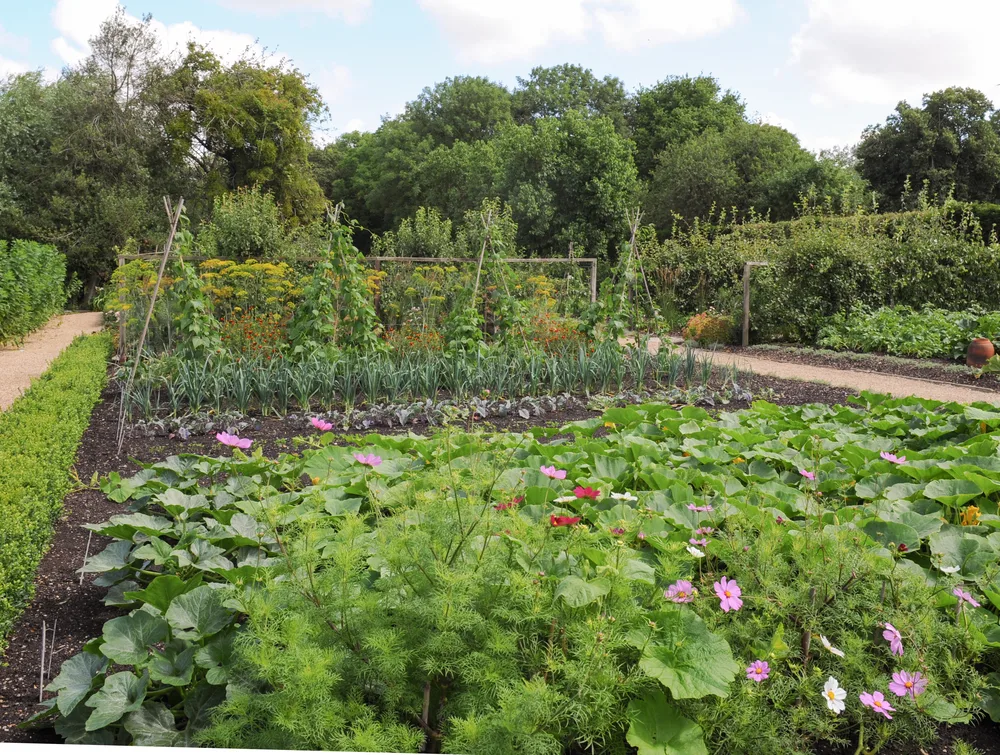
(418, 0, 746, 63)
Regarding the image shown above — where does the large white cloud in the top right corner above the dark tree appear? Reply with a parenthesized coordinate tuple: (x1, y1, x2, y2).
(791, 0, 1000, 107)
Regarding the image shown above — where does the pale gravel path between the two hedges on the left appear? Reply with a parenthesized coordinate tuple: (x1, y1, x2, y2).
(0, 312, 104, 411)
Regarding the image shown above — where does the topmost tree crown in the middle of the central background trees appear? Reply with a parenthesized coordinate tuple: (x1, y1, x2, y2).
(513, 63, 626, 134)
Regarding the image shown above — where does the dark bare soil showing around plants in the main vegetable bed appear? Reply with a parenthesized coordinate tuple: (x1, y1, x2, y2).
(0, 375, 1000, 755)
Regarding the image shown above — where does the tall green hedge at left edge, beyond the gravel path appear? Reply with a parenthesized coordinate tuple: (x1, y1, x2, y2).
(0, 240, 66, 344)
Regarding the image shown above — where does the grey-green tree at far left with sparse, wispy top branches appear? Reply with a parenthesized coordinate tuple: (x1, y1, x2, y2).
(0, 11, 169, 297)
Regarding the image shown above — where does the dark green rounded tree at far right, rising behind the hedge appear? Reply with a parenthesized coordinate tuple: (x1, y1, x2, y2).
(856, 87, 1000, 208)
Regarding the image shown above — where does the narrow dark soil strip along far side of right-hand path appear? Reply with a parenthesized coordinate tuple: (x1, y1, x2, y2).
(727, 346, 1000, 391)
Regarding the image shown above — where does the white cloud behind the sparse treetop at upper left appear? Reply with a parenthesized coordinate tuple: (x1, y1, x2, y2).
(52, 0, 273, 65)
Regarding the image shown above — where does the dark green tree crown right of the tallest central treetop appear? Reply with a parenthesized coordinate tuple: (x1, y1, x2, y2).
(629, 76, 745, 178)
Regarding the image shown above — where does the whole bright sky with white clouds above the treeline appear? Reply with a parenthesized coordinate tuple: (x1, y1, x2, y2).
(0, 0, 1000, 150)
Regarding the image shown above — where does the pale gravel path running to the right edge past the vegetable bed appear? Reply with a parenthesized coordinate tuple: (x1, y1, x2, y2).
(620, 338, 1000, 406)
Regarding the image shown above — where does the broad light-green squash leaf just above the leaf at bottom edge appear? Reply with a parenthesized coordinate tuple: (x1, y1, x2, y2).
(639, 607, 740, 700)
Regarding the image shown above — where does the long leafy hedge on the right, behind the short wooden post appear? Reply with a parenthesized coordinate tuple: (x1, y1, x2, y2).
(646, 206, 1000, 342)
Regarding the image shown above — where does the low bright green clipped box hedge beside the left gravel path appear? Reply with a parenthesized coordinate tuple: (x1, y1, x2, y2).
(0, 333, 111, 652)
